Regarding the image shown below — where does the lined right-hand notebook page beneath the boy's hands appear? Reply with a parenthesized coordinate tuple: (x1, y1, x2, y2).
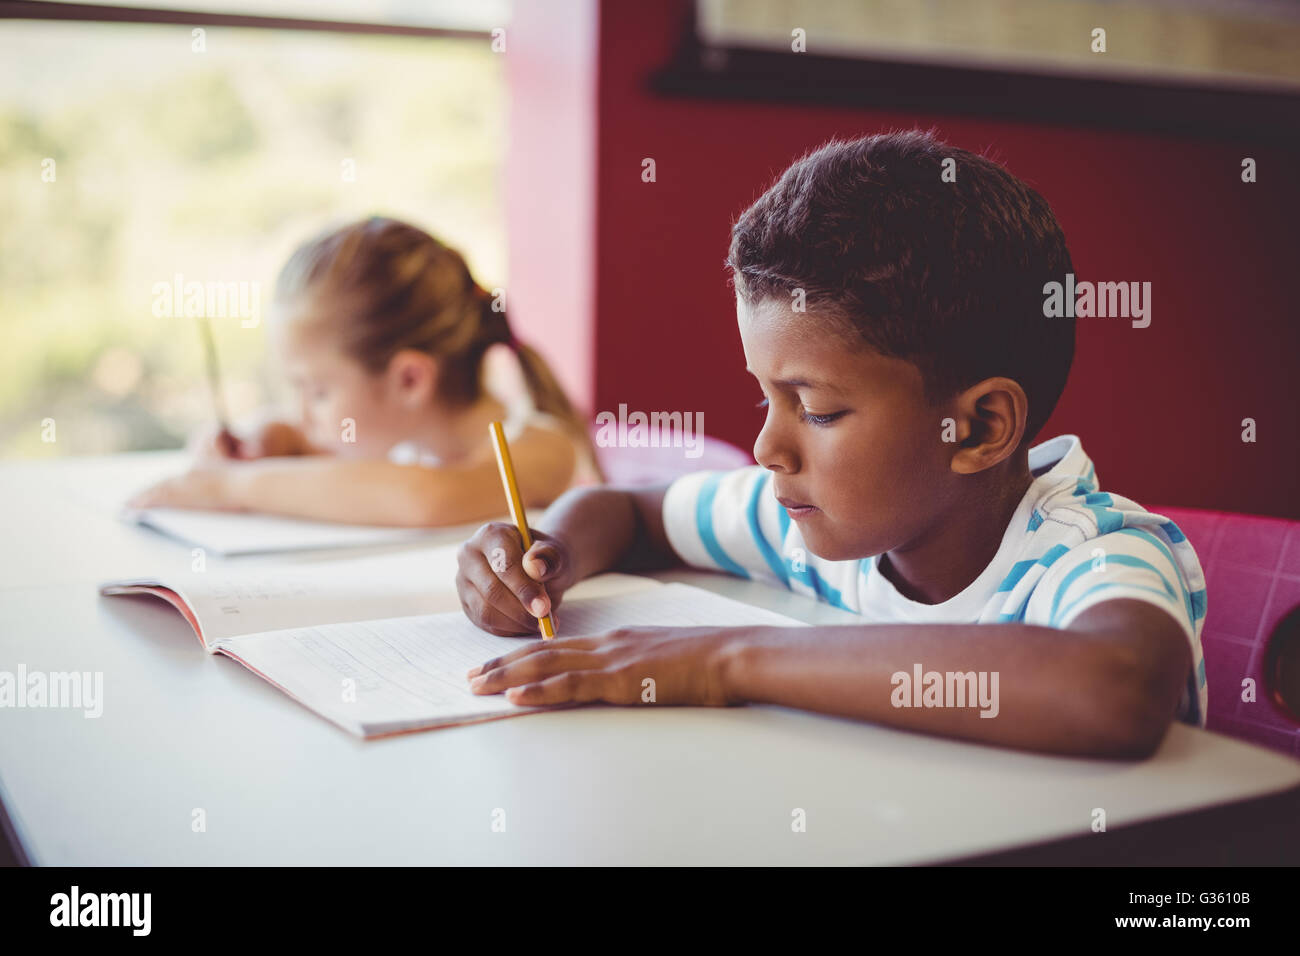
(221, 584, 801, 736)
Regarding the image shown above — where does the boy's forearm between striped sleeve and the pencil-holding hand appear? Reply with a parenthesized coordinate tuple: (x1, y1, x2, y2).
(537, 488, 680, 583)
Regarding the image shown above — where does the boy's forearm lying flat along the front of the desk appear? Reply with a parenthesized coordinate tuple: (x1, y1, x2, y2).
(719, 624, 1173, 757)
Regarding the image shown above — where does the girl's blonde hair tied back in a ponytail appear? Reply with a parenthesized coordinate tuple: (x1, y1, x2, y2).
(276, 216, 605, 481)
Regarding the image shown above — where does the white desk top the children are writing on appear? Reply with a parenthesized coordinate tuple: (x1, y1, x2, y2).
(0, 453, 1300, 865)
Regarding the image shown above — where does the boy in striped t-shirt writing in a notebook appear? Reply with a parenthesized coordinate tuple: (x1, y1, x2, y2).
(456, 131, 1206, 757)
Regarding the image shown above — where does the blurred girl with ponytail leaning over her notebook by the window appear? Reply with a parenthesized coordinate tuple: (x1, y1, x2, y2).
(130, 217, 603, 525)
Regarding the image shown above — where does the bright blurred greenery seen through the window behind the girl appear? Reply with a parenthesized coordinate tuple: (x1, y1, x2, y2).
(0, 21, 506, 458)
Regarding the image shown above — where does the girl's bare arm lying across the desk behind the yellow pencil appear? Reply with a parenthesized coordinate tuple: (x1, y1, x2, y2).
(130, 429, 576, 527)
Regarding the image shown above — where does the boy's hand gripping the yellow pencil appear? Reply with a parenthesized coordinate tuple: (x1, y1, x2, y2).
(456, 522, 575, 637)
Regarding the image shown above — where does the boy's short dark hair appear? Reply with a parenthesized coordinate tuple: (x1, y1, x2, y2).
(727, 130, 1074, 442)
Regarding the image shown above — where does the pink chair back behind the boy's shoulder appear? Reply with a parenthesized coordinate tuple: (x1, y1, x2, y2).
(1145, 505, 1300, 757)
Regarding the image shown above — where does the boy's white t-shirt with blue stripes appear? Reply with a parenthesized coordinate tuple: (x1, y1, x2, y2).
(663, 434, 1206, 727)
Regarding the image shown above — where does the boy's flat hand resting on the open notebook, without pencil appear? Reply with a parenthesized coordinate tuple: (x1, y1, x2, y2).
(467, 627, 750, 706)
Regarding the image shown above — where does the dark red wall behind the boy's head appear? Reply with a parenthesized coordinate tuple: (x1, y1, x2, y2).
(511, 0, 1300, 518)
